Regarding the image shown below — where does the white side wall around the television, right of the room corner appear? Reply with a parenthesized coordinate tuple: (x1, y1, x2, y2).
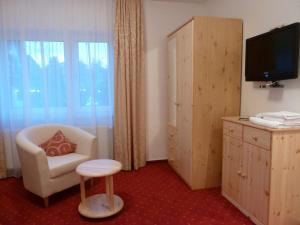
(204, 0, 300, 116)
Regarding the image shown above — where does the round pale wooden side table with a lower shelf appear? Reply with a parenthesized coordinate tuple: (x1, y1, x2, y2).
(76, 159, 124, 218)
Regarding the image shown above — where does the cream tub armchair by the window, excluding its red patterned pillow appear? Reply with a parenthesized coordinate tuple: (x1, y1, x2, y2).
(16, 124, 96, 207)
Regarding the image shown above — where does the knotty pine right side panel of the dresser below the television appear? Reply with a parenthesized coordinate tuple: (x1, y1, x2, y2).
(269, 131, 300, 225)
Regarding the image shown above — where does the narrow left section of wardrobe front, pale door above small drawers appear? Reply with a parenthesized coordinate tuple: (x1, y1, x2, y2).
(168, 34, 177, 170)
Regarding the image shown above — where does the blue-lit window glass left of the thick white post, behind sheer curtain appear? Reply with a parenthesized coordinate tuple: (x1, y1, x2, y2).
(8, 41, 66, 108)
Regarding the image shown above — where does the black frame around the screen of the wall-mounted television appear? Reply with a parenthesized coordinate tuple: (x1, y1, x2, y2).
(245, 22, 300, 81)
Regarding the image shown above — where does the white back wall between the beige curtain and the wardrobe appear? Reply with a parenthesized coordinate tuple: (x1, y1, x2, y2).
(144, 0, 203, 160)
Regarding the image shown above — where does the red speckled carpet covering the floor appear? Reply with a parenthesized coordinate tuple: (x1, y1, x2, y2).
(0, 162, 253, 225)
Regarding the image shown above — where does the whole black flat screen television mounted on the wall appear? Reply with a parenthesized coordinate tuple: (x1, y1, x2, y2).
(245, 23, 300, 81)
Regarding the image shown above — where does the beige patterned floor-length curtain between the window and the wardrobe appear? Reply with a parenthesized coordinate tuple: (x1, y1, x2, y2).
(114, 0, 146, 170)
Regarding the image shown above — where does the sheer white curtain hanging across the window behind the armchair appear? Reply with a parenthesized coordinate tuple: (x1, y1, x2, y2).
(0, 0, 113, 175)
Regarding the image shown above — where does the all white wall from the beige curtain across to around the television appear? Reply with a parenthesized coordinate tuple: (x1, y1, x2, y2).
(144, 0, 300, 160)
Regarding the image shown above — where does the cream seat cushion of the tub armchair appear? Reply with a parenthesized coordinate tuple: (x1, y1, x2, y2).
(47, 153, 89, 178)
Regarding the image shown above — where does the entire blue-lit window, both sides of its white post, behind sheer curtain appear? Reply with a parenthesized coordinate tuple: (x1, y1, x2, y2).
(7, 40, 111, 110)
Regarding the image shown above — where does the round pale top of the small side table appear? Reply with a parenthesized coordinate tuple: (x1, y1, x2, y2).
(76, 159, 122, 177)
